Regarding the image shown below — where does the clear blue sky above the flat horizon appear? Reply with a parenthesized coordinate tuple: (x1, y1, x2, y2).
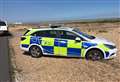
(0, 0, 120, 22)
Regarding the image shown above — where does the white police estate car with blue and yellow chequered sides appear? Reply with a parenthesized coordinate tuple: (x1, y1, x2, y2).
(20, 26, 117, 60)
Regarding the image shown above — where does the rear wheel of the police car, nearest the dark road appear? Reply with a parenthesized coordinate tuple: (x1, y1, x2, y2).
(29, 46, 42, 58)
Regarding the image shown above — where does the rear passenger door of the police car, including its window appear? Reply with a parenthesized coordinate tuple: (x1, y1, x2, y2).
(41, 30, 59, 55)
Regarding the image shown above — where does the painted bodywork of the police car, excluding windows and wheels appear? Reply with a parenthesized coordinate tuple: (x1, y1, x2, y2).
(20, 29, 117, 59)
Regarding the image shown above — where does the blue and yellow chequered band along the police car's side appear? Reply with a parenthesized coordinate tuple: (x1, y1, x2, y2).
(21, 36, 109, 57)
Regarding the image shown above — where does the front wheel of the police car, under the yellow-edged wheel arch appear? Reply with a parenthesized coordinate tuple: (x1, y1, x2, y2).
(86, 49, 103, 60)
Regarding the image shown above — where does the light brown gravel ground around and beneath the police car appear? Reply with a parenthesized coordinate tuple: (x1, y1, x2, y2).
(10, 23, 120, 82)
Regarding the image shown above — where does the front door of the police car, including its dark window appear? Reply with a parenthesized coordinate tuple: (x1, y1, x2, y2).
(59, 30, 82, 57)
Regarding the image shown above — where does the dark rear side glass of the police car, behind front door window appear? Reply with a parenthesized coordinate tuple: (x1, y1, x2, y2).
(31, 30, 57, 38)
